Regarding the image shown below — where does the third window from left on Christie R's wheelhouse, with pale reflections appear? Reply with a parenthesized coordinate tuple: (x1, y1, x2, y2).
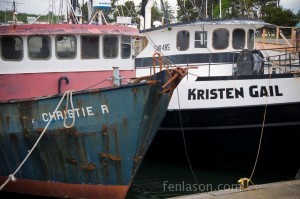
(55, 35, 76, 59)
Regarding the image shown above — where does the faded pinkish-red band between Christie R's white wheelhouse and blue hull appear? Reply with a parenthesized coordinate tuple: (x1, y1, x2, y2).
(0, 70, 135, 101)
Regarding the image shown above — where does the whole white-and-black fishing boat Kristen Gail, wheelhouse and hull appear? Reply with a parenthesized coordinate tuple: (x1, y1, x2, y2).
(135, 0, 300, 176)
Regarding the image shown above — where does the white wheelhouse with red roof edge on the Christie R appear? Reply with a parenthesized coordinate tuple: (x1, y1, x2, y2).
(0, 25, 141, 74)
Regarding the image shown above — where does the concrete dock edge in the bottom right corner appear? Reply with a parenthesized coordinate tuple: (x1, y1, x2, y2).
(172, 179, 300, 199)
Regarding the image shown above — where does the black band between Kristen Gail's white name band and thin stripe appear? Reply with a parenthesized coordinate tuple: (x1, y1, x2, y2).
(159, 103, 300, 131)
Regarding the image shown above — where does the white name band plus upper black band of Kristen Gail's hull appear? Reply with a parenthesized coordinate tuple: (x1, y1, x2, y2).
(160, 74, 300, 130)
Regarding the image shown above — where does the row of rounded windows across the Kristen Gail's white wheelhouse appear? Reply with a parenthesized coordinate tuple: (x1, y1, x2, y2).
(176, 28, 254, 51)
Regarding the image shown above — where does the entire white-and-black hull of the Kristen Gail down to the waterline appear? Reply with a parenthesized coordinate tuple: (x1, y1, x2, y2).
(155, 74, 300, 179)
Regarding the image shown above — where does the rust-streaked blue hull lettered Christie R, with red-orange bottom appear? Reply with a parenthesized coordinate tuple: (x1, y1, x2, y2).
(0, 71, 184, 198)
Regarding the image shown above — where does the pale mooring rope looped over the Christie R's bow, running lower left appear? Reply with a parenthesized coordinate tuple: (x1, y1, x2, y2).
(0, 90, 75, 191)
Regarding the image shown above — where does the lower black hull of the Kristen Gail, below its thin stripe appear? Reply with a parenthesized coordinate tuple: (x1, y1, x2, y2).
(147, 126, 300, 178)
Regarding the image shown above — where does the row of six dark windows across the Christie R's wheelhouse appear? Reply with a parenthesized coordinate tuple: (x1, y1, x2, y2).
(1, 35, 132, 60)
